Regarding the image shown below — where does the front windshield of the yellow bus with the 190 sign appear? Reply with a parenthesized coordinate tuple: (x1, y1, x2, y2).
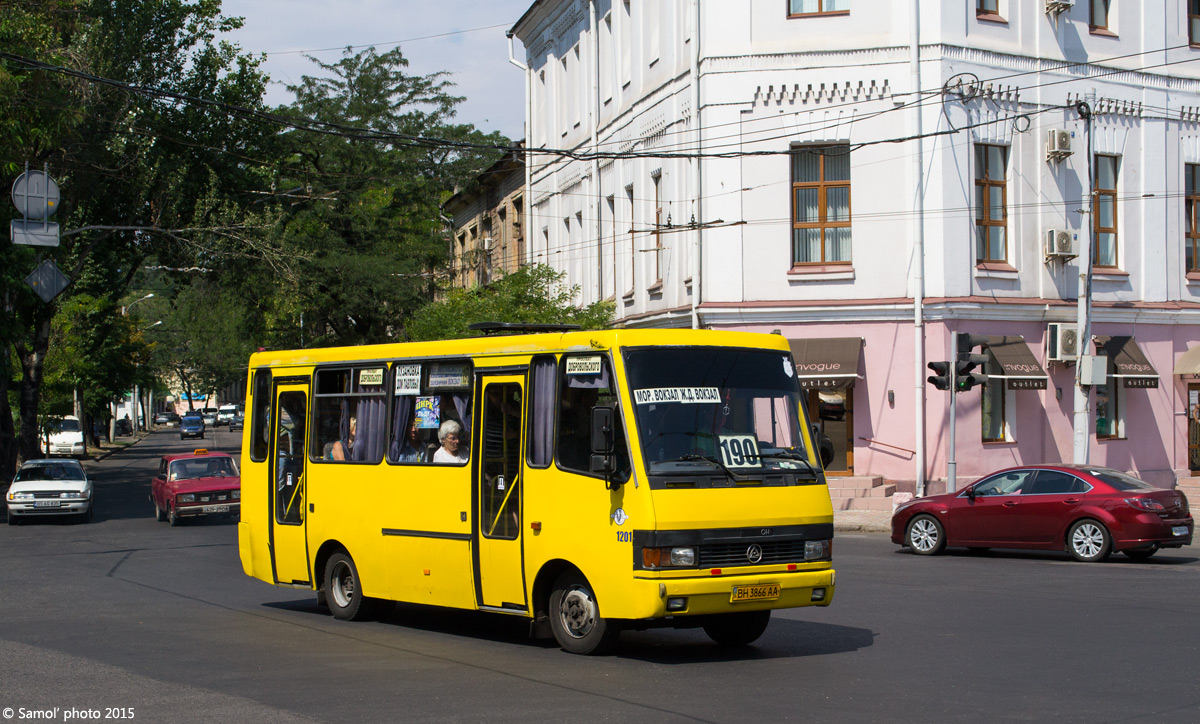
(624, 347, 820, 480)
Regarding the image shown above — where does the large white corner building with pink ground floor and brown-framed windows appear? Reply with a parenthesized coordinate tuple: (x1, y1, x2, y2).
(511, 0, 1200, 490)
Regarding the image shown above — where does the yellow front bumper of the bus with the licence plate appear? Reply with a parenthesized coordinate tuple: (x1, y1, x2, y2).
(640, 568, 836, 618)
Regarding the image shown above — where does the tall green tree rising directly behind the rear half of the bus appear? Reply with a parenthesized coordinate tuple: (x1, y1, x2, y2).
(242, 48, 508, 347)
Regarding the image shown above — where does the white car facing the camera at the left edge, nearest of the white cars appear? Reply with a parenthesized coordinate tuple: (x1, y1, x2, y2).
(5, 460, 95, 526)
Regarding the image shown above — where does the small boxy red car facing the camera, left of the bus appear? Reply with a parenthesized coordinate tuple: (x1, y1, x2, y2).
(150, 448, 241, 526)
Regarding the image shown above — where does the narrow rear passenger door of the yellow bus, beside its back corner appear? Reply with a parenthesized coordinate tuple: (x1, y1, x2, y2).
(270, 384, 312, 585)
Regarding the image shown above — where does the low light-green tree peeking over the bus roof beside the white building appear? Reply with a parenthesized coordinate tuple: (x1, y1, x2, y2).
(404, 264, 616, 341)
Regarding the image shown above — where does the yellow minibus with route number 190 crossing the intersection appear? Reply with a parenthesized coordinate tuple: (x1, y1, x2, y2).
(238, 324, 834, 653)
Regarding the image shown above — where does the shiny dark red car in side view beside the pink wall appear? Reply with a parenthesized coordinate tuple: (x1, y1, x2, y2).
(892, 465, 1194, 562)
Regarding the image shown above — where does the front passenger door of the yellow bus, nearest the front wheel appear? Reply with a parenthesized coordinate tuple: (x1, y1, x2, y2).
(475, 377, 527, 610)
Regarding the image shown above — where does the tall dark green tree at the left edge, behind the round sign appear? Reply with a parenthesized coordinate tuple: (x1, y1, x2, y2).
(0, 0, 275, 471)
